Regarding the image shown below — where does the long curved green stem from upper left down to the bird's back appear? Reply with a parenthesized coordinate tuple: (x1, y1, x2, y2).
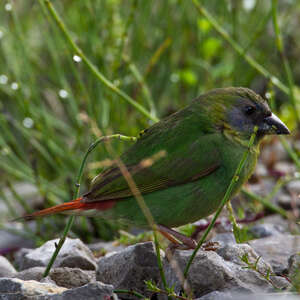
(40, 0, 159, 122)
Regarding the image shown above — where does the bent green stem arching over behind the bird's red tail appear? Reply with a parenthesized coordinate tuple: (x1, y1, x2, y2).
(43, 134, 136, 277)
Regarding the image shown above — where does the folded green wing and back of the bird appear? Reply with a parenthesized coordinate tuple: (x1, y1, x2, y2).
(84, 105, 221, 202)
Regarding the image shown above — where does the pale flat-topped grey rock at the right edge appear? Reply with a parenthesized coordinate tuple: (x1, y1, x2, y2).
(249, 234, 300, 275)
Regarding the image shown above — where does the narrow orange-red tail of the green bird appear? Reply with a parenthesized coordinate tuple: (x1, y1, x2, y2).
(14, 197, 85, 221)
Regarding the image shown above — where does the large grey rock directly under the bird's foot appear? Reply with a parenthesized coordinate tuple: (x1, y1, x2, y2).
(164, 244, 288, 297)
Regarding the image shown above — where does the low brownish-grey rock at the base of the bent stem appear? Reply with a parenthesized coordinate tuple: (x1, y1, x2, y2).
(15, 267, 96, 288)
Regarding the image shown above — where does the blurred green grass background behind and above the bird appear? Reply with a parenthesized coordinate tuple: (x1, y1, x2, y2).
(0, 0, 300, 246)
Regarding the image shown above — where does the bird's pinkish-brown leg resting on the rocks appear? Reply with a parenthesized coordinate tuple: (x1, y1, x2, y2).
(157, 225, 197, 250)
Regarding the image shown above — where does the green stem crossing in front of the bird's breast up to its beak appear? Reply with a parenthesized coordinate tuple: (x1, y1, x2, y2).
(184, 126, 258, 278)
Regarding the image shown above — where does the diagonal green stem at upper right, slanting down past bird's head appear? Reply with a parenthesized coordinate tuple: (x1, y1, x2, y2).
(193, 0, 289, 94)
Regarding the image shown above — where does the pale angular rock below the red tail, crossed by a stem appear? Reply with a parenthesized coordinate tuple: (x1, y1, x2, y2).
(17, 238, 97, 270)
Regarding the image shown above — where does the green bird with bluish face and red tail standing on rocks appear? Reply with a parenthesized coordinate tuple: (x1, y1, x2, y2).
(20, 87, 289, 248)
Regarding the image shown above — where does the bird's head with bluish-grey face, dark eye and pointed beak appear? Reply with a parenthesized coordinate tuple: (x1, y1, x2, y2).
(193, 87, 290, 141)
